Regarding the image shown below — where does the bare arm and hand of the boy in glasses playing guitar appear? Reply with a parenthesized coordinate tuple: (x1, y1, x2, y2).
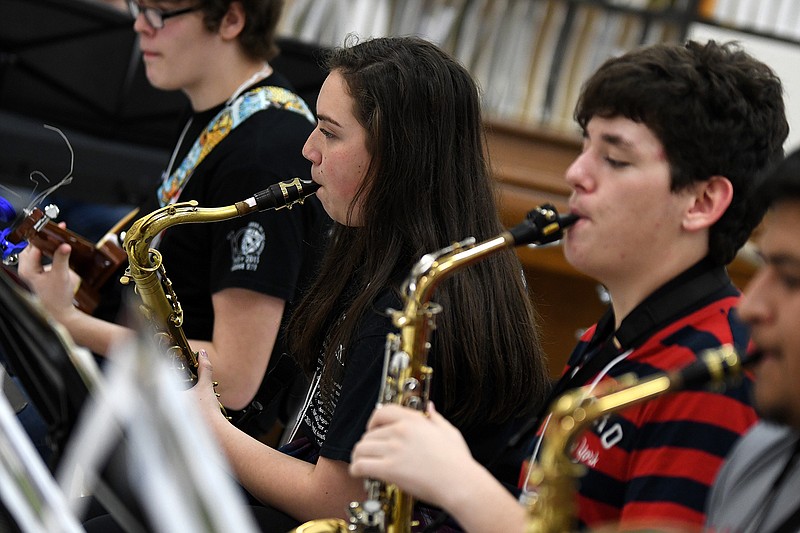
(19, 244, 284, 409)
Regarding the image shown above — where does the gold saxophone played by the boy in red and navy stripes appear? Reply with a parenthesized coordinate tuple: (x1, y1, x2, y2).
(292, 205, 577, 533)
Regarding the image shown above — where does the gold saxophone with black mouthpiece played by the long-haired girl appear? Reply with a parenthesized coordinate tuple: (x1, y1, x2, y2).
(120, 178, 319, 388)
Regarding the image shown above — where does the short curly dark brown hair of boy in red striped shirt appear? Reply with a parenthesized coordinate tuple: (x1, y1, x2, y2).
(575, 41, 789, 265)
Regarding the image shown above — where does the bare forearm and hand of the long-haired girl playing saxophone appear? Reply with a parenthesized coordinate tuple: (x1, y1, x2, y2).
(191, 354, 365, 521)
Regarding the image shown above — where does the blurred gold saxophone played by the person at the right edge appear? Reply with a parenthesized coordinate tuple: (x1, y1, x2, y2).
(525, 345, 752, 533)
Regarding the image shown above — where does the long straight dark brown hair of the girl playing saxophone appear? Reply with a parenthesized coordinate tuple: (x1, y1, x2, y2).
(289, 37, 547, 423)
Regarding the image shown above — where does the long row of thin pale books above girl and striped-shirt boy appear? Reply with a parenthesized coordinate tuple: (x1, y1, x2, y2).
(279, 0, 689, 132)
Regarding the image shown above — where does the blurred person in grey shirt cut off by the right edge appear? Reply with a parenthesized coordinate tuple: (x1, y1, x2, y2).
(706, 151, 800, 533)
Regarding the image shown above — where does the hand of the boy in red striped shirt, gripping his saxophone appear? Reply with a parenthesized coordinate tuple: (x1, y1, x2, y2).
(350, 402, 482, 506)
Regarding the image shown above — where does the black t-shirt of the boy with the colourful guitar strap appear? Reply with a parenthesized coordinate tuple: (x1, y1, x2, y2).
(136, 74, 330, 404)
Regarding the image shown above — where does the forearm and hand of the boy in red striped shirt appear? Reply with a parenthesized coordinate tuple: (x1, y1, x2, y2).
(350, 405, 526, 533)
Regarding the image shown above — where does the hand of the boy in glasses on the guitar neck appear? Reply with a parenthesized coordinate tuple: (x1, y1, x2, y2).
(18, 235, 83, 323)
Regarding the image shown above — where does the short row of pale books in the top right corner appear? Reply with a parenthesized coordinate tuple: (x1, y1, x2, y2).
(702, 0, 800, 41)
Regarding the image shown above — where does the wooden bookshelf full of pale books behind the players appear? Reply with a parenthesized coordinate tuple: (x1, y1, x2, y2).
(279, 0, 800, 376)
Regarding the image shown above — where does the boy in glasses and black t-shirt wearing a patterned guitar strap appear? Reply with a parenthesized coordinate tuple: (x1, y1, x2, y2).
(20, 0, 325, 436)
